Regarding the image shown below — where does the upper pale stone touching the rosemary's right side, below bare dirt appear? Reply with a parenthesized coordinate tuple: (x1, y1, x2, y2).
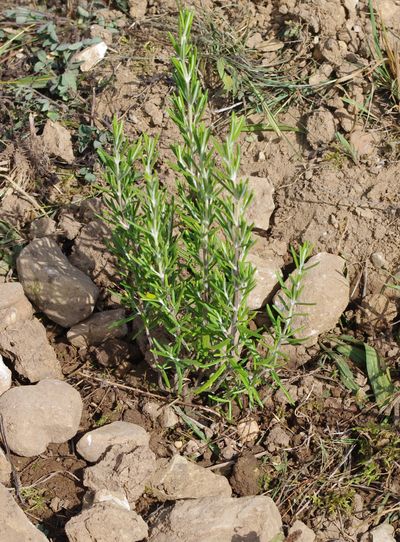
(246, 177, 275, 231)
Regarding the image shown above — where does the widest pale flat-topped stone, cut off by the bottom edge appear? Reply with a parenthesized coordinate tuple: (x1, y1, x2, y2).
(148, 496, 282, 542)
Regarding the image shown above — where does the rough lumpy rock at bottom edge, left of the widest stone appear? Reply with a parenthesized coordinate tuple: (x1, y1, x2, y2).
(65, 502, 148, 542)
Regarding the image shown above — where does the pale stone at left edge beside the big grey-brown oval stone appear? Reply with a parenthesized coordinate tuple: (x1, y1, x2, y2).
(0, 282, 33, 332)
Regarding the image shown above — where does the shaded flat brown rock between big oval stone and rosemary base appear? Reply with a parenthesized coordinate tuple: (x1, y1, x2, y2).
(67, 309, 128, 348)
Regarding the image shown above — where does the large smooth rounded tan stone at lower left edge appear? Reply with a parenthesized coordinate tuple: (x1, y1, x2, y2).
(0, 379, 82, 457)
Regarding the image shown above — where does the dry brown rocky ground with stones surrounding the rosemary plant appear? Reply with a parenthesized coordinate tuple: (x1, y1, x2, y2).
(0, 0, 400, 542)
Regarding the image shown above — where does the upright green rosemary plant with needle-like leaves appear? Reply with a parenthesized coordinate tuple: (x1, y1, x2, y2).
(99, 11, 306, 412)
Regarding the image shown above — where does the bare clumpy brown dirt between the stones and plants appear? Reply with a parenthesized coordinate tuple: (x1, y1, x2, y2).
(0, 0, 400, 542)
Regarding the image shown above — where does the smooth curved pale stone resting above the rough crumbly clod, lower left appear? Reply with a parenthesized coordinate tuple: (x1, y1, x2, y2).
(76, 422, 150, 463)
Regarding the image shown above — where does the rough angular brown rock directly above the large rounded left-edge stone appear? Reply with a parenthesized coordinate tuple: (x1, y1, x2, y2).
(0, 318, 63, 382)
